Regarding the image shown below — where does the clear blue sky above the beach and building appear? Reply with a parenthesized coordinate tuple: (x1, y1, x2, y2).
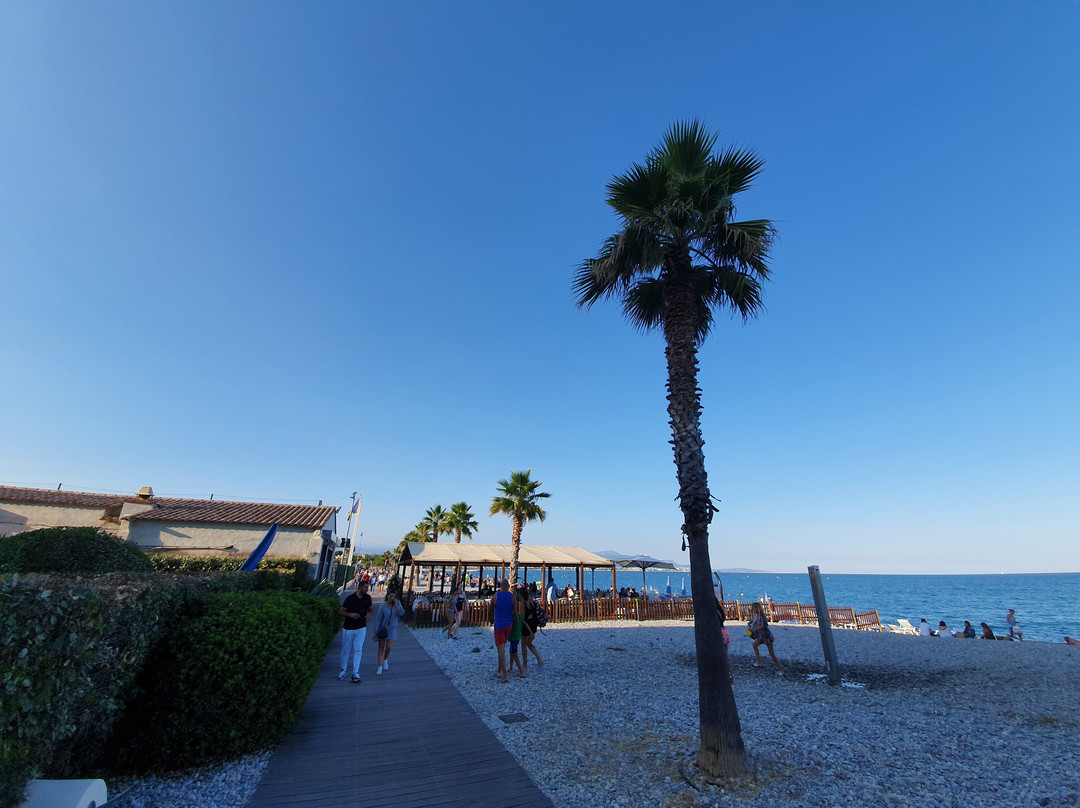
(0, 2, 1080, 573)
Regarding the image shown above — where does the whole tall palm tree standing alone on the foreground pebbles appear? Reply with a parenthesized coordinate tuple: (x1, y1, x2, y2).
(573, 121, 775, 777)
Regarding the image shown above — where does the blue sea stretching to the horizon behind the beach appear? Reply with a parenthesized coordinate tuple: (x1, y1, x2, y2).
(535, 569, 1080, 643)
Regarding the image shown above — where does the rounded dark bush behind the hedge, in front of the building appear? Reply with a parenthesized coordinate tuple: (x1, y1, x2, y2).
(0, 527, 153, 575)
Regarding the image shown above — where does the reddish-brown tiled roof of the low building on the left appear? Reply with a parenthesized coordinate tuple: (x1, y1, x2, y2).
(0, 486, 337, 530)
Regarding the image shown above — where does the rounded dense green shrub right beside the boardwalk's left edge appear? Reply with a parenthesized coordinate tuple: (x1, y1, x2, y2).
(109, 591, 339, 771)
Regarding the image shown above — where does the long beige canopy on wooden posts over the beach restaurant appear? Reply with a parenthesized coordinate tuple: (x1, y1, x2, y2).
(397, 541, 616, 592)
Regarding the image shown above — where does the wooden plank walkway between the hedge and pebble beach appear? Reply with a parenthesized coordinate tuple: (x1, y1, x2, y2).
(248, 591, 552, 808)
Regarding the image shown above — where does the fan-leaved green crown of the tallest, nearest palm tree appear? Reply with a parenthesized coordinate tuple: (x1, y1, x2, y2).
(573, 121, 774, 344)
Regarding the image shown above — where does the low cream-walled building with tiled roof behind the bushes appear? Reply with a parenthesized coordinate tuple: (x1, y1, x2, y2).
(0, 486, 338, 579)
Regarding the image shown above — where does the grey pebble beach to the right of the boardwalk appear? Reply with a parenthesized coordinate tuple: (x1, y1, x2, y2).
(414, 621, 1080, 808)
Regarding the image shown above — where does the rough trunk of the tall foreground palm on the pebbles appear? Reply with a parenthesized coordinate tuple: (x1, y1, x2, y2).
(664, 255, 748, 777)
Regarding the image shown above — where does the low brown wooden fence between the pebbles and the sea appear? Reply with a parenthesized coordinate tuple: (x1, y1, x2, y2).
(410, 597, 882, 631)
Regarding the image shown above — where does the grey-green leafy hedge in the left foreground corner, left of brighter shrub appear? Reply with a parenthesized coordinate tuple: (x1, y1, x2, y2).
(0, 575, 186, 808)
